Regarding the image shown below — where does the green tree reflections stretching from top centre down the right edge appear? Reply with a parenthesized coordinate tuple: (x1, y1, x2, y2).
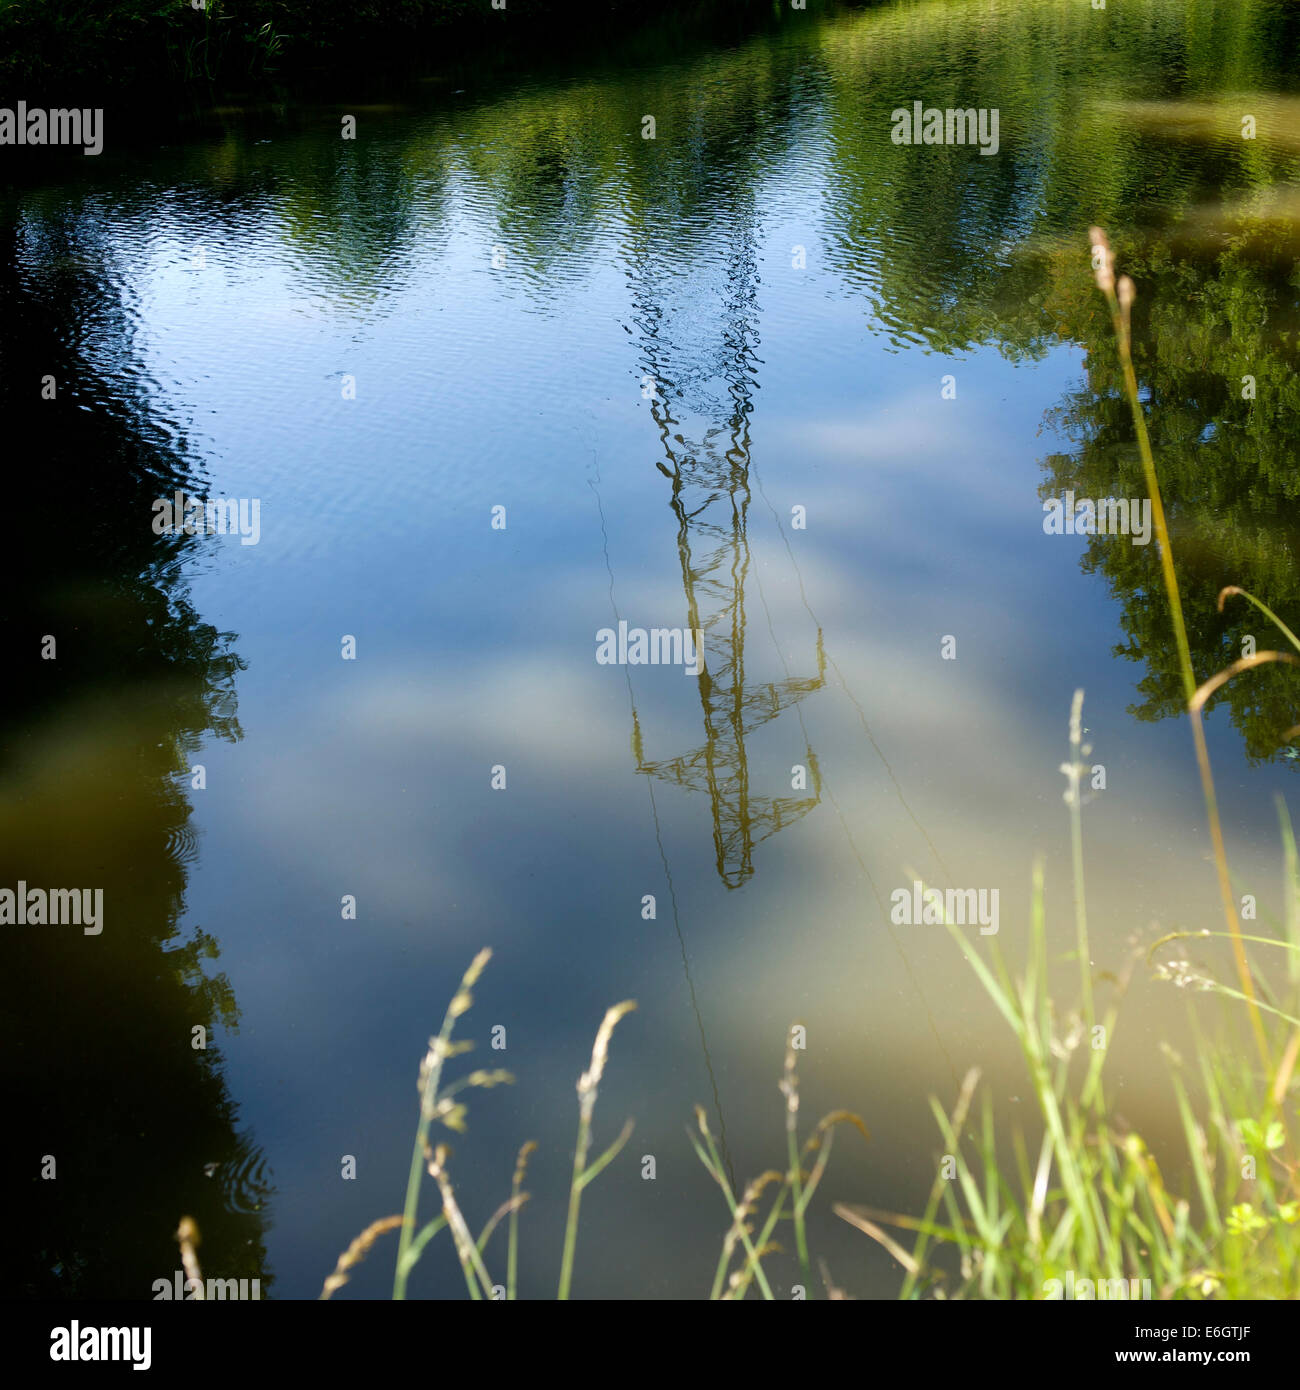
(408, 0, 1300, 758)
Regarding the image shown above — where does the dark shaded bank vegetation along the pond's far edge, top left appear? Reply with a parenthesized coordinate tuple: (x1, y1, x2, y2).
(0, 0, 848, 110)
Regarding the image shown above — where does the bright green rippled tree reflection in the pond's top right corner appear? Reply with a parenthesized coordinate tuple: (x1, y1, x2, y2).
(822, 0, 1300, 357)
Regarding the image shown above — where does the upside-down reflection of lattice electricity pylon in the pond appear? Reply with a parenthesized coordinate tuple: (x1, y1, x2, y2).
(633, 198, 826, 888)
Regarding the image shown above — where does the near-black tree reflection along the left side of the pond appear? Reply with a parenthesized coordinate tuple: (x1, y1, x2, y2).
(0, 215, 270, 1300)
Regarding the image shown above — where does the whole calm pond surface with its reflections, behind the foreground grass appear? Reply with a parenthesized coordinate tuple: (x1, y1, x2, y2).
(0, 0, 1300, 1298)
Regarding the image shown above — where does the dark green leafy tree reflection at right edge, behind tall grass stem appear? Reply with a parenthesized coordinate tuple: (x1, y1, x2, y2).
(1043, 221, 1300, 759)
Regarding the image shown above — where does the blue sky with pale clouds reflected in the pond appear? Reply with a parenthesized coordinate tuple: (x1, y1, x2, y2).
(10, 0, 1290, 1297)
